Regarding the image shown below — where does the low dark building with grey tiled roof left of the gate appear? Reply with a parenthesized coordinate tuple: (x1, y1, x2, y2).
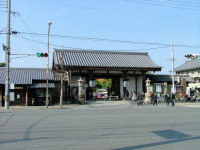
(0, 67, 56, 106)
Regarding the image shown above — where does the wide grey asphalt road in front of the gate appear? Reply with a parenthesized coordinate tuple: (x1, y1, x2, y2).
(0, 102, 200, 150)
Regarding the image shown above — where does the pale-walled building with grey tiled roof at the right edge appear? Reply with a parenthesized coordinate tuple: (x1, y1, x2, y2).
(174, 59, 200, 97)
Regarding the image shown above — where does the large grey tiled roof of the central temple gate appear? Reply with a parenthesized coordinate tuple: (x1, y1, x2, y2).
(53, 49, 161, 71)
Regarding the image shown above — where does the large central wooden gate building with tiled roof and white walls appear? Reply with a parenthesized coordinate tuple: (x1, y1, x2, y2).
(53, 49, 161, 102)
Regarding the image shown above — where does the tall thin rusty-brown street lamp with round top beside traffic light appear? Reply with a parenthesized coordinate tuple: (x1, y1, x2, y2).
(46, 21, 52, 108)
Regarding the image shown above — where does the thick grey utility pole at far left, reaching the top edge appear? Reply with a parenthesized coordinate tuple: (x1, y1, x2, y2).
(5, 0, 11, 109)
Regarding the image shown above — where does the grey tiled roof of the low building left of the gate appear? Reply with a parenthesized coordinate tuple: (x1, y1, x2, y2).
(0, 67, 54, 84)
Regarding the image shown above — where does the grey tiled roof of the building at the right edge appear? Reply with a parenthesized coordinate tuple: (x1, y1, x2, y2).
(174, 59, 200, 72)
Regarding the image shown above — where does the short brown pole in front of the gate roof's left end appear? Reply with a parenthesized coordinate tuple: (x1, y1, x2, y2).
(60, 50, 64, 108)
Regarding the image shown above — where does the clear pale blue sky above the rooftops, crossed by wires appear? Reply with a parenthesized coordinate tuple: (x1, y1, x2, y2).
(0, 0, 200, 74)
